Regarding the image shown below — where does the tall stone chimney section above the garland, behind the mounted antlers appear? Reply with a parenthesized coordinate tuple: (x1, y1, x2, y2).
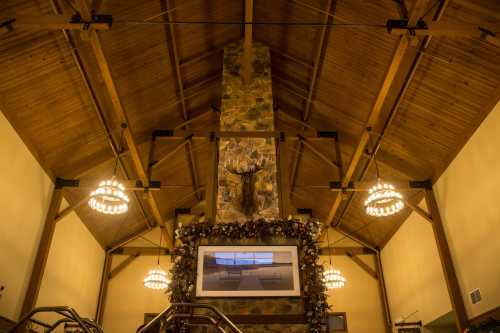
(216, 42, 279, 223)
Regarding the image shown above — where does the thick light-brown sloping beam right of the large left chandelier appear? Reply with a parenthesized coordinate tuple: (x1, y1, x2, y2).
(85, 31, 173, 246)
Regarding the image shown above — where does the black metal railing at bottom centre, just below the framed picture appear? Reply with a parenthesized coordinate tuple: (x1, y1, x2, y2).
(137, 303, 243, 333)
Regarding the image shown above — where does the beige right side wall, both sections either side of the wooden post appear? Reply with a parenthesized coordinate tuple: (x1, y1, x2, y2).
(382, 99, 500, 322)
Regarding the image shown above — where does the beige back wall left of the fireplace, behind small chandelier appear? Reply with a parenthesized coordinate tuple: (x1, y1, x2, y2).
(103, 229, 170, 333)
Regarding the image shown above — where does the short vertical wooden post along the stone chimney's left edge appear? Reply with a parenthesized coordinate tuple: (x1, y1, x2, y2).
(205, 137, 219, 223)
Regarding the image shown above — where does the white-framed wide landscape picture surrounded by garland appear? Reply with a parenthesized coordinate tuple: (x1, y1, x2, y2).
(196, 246, 300, 297)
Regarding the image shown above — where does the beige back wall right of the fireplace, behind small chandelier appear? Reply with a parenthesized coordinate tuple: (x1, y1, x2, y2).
(321, 231, 385, 333)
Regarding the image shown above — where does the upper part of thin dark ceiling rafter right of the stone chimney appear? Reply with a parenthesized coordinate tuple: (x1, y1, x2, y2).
(302, 0, 333, 121)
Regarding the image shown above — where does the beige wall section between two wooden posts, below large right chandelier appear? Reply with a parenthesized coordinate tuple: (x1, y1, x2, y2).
(382, 205, 451, 323)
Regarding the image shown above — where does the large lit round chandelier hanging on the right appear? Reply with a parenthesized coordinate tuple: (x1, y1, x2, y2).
(365, 180, 404, 217)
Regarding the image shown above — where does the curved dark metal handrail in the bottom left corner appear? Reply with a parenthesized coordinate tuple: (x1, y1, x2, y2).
(7, 306, 103, 333)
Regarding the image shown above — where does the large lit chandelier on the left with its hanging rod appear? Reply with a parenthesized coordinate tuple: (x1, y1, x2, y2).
(89, 124, 129, 215)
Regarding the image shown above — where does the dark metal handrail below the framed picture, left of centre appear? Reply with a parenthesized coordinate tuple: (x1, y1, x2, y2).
(137, 303, 243, 333)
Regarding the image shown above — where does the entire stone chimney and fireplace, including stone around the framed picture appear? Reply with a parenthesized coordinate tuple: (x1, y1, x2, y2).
(195, 42, 308, 333)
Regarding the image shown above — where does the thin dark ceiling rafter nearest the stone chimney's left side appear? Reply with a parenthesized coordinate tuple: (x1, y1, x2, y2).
(160, 0, 201, 200)
